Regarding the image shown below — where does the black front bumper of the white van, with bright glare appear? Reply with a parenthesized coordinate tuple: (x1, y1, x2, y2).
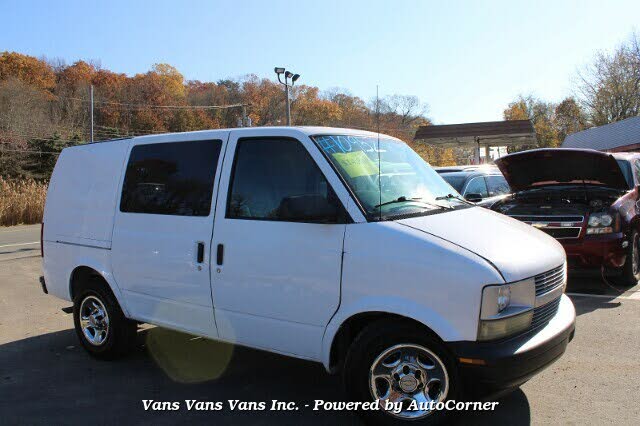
(449, 295, 575, 396)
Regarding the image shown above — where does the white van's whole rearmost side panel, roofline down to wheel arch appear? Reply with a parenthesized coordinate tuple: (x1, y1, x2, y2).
(43, 140, 130, 304)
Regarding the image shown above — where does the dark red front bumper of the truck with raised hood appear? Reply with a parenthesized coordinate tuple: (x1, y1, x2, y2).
(558, 232, 627, 268)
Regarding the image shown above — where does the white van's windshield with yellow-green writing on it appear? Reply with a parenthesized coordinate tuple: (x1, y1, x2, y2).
(313, 135, 468, 220)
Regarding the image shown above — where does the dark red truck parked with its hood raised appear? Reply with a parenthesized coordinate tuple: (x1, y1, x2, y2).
(493, 148, 640, 285)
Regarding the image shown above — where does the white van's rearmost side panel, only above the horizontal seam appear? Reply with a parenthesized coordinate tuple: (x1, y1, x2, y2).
(44, 140, 129, 248)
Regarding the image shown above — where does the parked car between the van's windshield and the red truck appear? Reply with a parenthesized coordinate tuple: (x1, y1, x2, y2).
(435, 165, 511, 207)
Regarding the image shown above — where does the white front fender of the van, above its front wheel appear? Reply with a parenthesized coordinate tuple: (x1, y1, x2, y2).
(322, 221, 504, 365)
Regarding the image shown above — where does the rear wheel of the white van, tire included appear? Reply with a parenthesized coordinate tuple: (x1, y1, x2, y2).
(73, 279, 137, 359)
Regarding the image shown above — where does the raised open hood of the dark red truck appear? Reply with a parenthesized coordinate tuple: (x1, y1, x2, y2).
(495, 148, 629, 192)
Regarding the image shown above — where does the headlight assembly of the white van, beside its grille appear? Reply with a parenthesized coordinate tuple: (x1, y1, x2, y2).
(478, 278, 536, 340)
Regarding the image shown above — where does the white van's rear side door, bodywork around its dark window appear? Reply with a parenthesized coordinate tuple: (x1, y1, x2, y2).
(111, 130, 229, 338)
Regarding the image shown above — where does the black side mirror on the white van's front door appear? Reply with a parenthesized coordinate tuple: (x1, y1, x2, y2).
(278, 194, 338, 223)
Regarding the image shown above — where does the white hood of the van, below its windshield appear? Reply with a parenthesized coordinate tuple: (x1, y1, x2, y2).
(397, 207, 566, 282)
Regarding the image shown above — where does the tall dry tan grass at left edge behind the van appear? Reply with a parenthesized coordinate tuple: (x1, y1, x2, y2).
(0, 176, 47, 226)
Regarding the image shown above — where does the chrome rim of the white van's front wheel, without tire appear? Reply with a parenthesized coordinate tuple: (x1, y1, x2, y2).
(369, 344, 449, 420)
